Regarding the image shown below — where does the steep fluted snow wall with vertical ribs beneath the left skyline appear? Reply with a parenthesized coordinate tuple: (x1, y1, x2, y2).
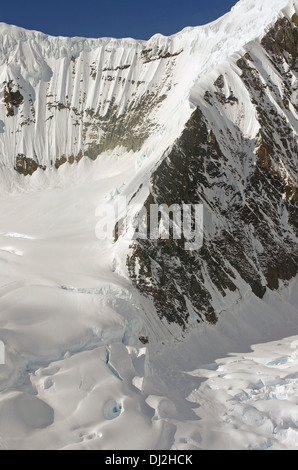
(0, 20, 186, 175)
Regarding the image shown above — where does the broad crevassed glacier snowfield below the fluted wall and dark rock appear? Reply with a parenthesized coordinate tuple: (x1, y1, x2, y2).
(0, 148, 298, 450)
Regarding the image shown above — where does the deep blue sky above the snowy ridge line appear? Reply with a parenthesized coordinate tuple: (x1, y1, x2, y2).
(0, 0, 236, 39)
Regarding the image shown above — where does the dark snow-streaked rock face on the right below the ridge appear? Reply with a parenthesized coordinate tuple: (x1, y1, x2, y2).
(127, 18, 298, 328)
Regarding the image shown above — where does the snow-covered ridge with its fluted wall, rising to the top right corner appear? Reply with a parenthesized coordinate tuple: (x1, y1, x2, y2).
(0, 0, 294, 174)
